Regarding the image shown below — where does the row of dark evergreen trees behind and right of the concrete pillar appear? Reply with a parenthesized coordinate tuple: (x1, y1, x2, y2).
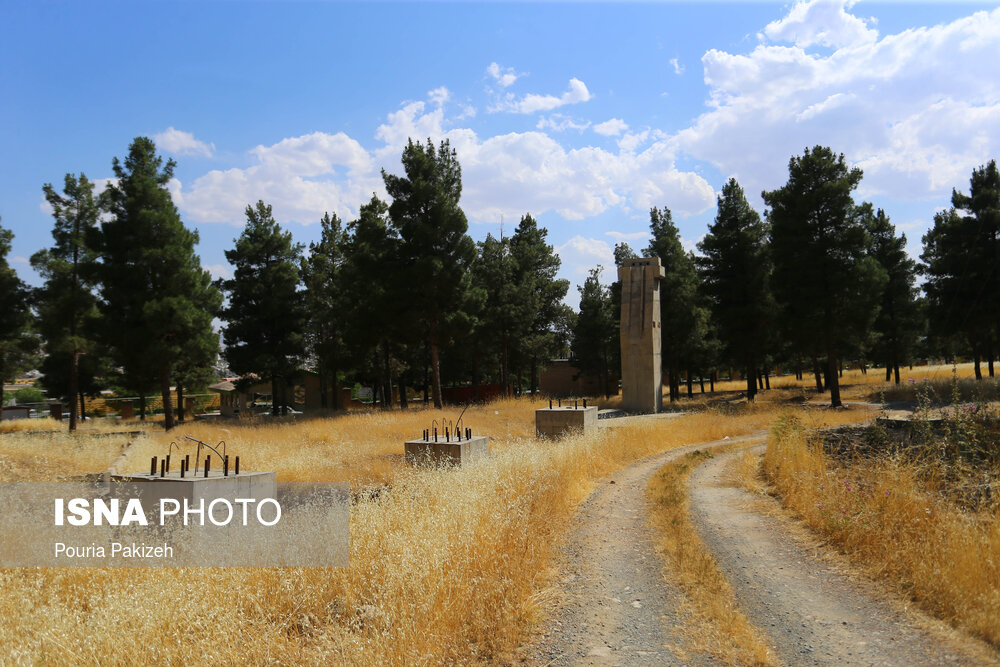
(573, 146, 1000, 406)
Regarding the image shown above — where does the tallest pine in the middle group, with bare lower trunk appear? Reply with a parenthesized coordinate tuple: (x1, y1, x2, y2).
(382, 139, 476, 408)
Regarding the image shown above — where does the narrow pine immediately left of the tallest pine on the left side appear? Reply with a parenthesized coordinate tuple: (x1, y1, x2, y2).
(31, 174, 101, 431)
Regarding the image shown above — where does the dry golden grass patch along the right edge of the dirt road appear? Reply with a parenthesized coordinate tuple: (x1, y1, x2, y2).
(764, 420, 1000, 646)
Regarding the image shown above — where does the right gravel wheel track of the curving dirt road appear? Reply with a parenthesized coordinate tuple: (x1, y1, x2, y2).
(690, 446, 988, 665)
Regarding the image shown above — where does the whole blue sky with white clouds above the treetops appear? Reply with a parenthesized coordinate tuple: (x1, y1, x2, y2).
(0, 0, 1000, 304)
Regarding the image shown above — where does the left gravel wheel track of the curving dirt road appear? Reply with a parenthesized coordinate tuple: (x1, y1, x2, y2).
(526, 434, 761, 665)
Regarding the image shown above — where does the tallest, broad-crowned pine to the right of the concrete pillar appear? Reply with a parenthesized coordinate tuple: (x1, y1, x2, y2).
(762, 146, 885, 407)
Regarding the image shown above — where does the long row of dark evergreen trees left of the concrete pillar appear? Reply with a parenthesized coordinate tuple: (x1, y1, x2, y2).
(0, 137, 572, 429)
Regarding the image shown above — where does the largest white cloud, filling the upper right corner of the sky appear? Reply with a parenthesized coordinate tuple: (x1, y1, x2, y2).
(676, 0, 1000, 203)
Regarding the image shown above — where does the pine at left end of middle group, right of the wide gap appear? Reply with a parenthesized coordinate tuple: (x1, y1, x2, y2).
(221, 201, 306, 416)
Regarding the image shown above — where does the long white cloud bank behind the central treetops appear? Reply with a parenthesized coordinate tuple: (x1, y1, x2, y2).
(175, 91, 715, 225)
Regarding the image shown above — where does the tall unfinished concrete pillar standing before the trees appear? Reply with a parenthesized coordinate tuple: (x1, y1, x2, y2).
(618, 257, 665, 413)
